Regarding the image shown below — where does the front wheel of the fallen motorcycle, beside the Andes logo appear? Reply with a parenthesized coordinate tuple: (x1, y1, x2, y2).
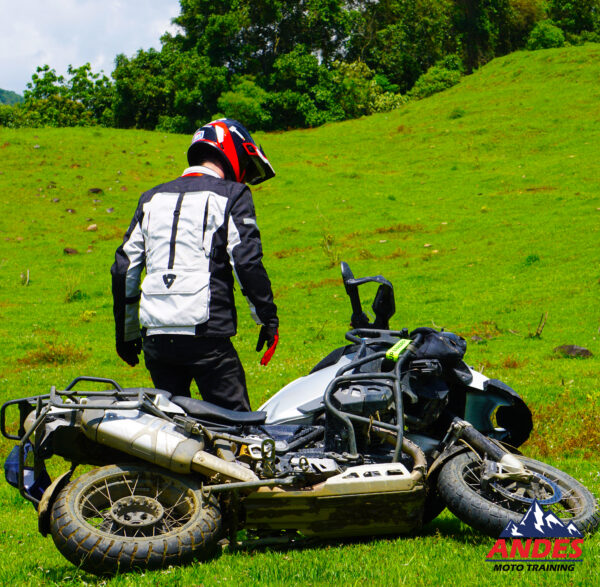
(437, 452, 600, 537)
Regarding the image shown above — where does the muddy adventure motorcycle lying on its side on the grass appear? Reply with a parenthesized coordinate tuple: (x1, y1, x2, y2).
(0, 263, 600, 575)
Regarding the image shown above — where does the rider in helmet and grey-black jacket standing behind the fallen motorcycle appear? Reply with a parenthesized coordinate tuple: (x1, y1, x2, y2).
(111, 119, 279, 410)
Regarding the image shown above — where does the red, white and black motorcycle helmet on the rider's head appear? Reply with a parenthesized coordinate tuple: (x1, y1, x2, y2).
(187, 118, 275, 185)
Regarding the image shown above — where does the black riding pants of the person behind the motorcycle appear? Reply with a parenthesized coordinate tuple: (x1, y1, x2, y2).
(143, 334, 250, 411)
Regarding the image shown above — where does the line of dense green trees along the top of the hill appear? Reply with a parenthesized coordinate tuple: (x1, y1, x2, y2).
(0, 0, 600, 132)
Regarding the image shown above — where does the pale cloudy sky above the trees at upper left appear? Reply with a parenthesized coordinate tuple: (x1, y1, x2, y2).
(0, 0, 179, 95)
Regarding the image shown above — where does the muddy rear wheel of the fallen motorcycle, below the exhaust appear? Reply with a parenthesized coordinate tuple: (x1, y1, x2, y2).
(50, 465, 221, 575)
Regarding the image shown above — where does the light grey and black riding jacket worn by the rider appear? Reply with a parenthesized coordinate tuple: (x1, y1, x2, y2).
(111, 167, 279, 341)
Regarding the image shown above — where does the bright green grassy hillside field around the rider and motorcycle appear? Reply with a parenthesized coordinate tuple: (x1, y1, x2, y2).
(0, 45, 600, 586)
